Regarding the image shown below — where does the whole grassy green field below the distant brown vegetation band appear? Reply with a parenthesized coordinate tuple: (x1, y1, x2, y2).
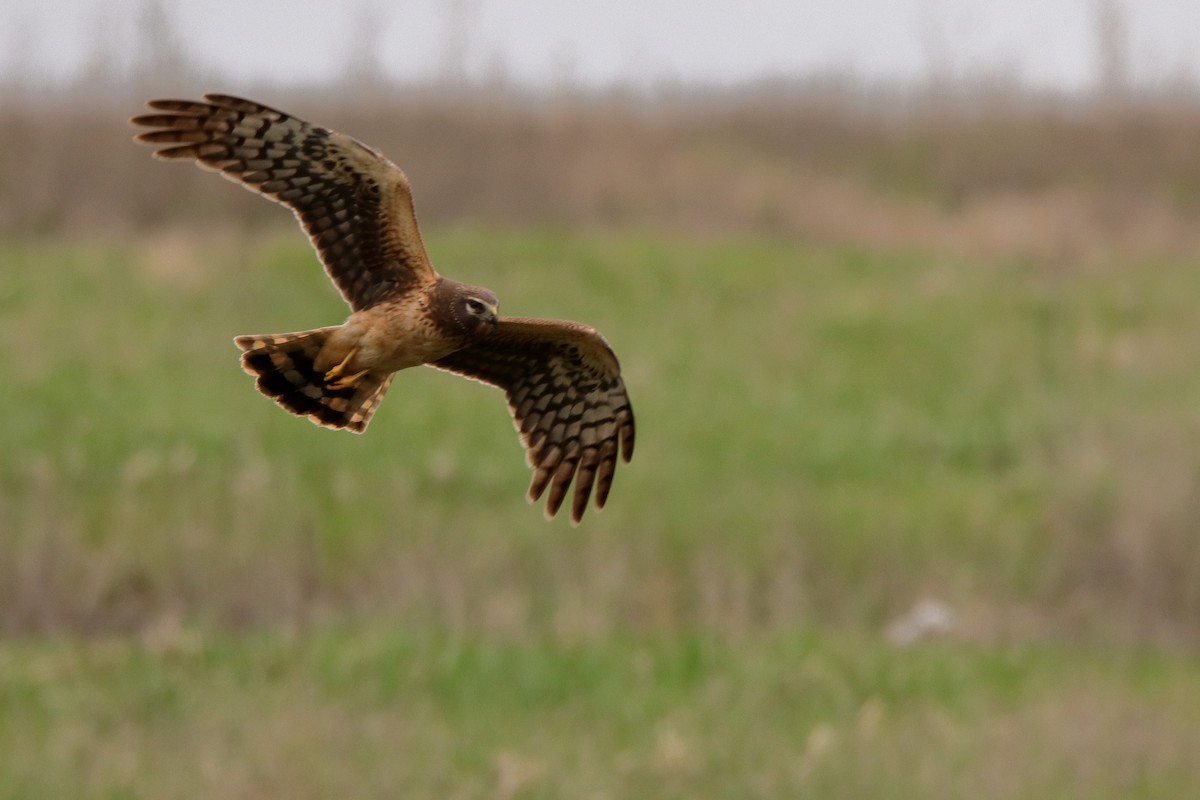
(0, 229, 1200, 798)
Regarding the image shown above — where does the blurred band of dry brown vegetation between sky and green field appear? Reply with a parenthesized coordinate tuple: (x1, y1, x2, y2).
(7, 85, 1200, 264)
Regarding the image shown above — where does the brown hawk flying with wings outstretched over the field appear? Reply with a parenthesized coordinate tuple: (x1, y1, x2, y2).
(131, 95, 634, 523)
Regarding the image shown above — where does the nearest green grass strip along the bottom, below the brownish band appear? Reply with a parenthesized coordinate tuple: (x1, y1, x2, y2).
(7, 625, 1200, 800)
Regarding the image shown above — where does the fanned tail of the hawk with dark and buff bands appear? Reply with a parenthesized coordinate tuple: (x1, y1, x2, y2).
(234, 327, 395, 433)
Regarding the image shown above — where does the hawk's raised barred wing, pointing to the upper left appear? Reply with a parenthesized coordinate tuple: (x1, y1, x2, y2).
(130, 95, 437, 311)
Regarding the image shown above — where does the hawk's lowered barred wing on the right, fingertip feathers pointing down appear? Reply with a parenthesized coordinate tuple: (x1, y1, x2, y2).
(430, 318, 634, 523)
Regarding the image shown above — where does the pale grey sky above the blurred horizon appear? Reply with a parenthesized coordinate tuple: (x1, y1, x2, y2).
(0, 0, 1200, 90)
